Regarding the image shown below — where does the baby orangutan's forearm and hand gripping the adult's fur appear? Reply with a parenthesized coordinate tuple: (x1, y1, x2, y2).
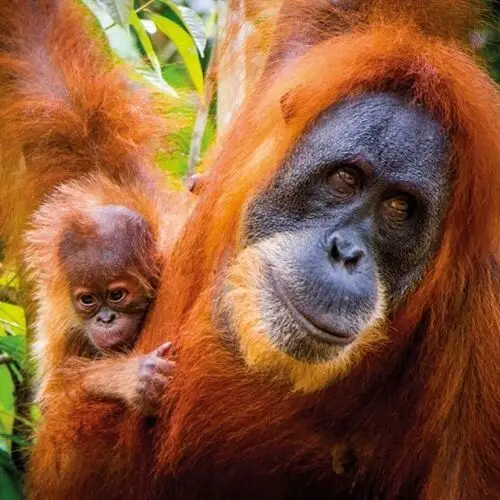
(62, 342, 175, 416)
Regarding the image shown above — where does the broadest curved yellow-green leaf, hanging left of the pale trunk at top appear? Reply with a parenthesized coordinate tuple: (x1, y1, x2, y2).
(149, 13, 204, 96)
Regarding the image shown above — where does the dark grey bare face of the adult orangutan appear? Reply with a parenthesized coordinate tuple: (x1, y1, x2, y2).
(238, 94, 450, 360)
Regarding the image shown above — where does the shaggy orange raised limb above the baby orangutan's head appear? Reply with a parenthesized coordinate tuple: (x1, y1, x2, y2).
(0, 0, 177, 266)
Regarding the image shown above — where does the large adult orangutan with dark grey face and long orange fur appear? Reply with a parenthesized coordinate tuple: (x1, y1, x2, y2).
(0, 0, 500, 500)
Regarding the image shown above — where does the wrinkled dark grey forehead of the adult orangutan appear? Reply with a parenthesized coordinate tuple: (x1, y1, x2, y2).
(288, 93, 449, 201)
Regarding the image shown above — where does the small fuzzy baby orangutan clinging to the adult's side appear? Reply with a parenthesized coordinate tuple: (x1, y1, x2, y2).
(26, 178, 180, 415)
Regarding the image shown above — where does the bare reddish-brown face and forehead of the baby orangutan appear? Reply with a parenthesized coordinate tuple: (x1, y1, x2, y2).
(60, 206, 154, 351)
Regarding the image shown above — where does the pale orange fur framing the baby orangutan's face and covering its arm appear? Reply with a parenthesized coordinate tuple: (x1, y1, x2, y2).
(24, 174, 189, 407)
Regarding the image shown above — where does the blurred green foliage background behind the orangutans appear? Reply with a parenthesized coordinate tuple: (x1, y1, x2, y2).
(0, 0, 500, 500)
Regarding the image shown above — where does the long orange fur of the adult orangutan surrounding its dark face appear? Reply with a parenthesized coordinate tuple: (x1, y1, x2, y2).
(4, 0, 500, 500)
